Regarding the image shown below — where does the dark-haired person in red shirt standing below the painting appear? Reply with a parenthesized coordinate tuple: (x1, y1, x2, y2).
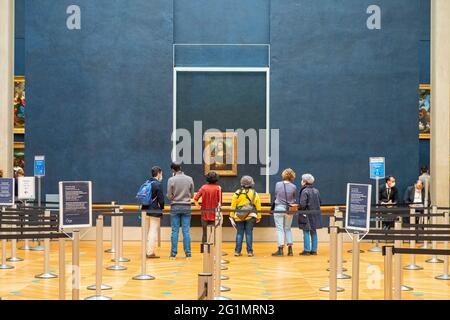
(194, 171, 222, 243)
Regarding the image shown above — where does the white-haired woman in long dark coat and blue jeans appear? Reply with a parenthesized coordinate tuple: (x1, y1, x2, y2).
(298, 173, 322, 256)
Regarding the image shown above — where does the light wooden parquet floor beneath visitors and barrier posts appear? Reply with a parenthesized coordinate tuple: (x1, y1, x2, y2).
(0, 241, 450, 300)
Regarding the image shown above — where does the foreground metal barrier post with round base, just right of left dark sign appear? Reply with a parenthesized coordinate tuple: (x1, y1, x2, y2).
(85, 215, 111, 300)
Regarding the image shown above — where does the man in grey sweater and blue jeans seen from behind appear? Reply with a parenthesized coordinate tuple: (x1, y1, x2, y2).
(167, 163, 194, 259)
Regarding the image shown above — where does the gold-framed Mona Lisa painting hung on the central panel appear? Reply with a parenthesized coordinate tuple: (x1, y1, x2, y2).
(203, 132, 237, 177)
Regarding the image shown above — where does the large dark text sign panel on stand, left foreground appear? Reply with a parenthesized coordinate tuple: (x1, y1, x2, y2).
(59, 181, 92, 229)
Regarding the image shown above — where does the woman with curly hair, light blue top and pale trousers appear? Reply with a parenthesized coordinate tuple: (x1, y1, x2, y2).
(272, 169, 297, 257)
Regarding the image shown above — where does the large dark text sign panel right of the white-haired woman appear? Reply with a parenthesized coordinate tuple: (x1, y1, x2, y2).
(345, 183, 372, 232)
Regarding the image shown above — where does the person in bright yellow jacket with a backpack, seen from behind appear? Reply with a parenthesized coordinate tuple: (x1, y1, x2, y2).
(230, 176, 261, 257)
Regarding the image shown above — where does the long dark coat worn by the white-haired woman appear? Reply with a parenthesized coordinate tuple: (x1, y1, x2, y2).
(298, 186, 322, 231)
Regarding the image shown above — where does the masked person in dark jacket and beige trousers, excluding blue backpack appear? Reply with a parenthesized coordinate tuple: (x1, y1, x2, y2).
(142, 166, 164, 259)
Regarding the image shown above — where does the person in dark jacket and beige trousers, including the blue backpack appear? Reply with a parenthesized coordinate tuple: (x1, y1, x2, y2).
(137, 166, 164, 259)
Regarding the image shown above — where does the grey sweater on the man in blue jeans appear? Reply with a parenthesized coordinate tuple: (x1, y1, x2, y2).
(167, 172, 194, 205)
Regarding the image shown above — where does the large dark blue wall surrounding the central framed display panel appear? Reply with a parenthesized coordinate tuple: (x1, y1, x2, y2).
(25, 0, 423, 211)
